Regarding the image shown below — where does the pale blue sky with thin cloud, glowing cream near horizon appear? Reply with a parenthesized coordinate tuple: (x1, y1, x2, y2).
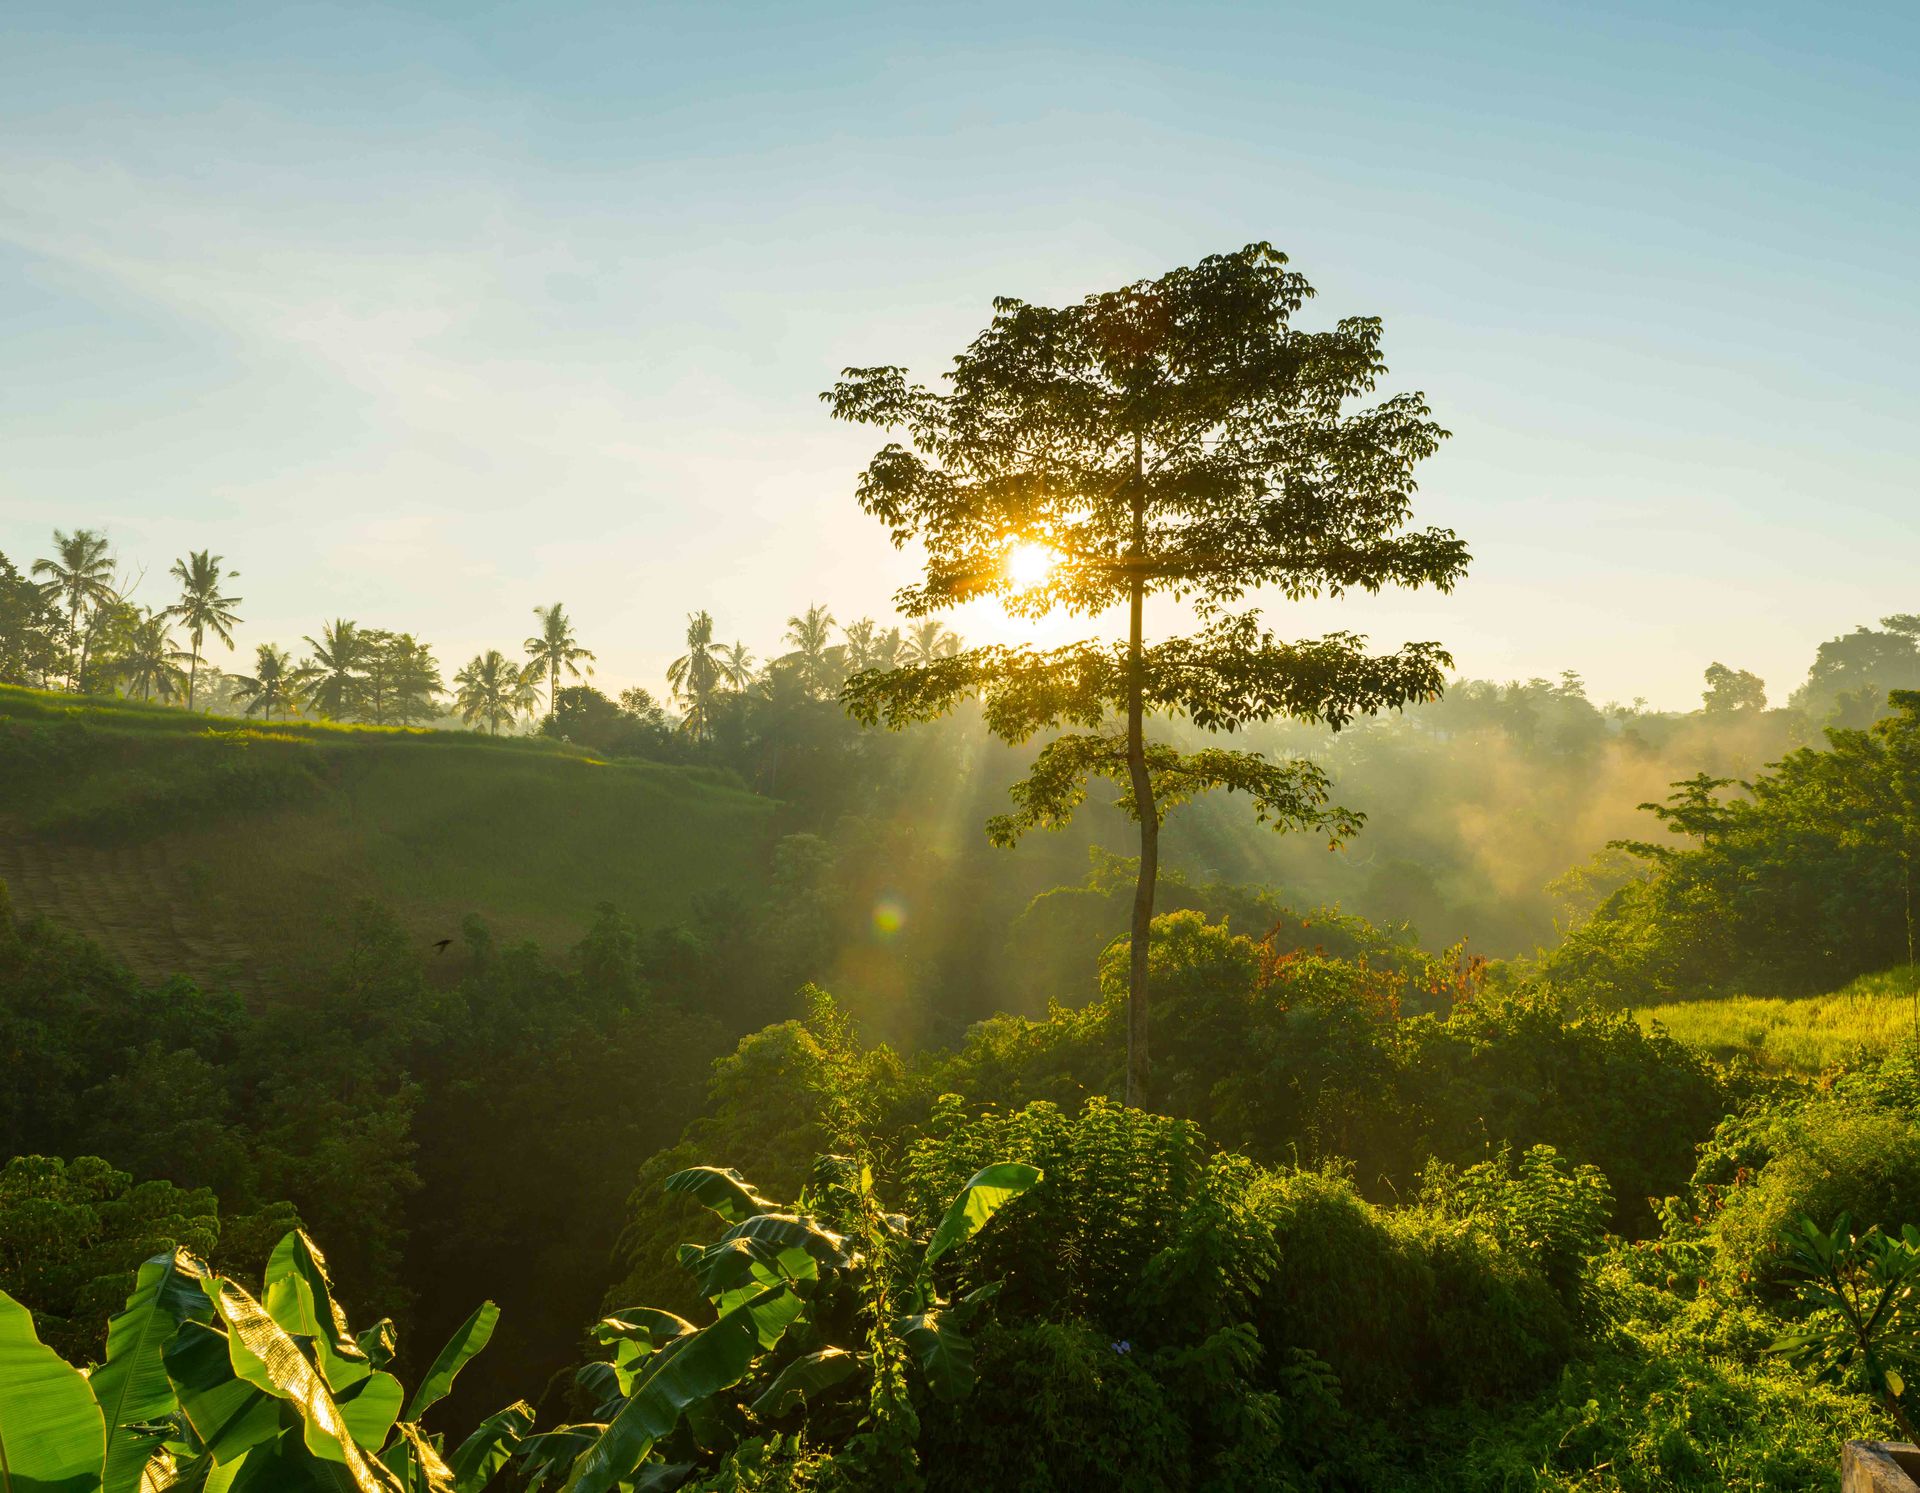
(0, 0, 1920, 708)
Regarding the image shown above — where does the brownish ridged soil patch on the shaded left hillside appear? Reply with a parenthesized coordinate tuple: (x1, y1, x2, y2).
(0, 821, 257, 988)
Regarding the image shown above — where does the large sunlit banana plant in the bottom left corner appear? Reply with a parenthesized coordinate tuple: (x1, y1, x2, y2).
(0, 1230, 534, 1493)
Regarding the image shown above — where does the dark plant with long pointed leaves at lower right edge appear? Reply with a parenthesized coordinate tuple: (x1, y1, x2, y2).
(1774, 1213, 1920, 1441)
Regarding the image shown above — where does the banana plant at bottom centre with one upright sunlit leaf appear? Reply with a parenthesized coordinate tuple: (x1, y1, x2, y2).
(537, 1157, 1041, 1493)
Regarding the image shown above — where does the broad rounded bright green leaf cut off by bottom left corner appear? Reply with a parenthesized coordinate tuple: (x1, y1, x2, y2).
(0, 1292, 108, 1493)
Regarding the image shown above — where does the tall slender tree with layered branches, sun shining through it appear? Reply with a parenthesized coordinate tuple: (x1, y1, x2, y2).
(822, 244, 1467, 1103)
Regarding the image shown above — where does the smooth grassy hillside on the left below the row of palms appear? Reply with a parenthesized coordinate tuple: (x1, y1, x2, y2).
(0, 687, 772, 984)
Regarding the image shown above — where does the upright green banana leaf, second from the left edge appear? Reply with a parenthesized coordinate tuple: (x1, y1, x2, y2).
(88, 1249, 213, 1493)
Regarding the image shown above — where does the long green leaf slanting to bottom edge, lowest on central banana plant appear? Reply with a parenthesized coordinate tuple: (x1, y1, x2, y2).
(564, 1288, 803, 1493)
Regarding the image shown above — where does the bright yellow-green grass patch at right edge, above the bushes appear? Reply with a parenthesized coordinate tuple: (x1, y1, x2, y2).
(1640, 965, 1920, 1073)
